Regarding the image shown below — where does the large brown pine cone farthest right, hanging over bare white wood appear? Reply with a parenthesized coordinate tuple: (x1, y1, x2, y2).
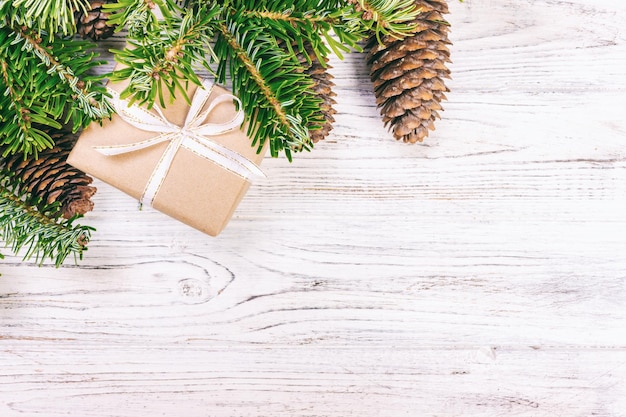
(367, 0, 450, 143)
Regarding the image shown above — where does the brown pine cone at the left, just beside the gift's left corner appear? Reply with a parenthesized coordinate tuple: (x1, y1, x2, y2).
(3, 127, 96, 219)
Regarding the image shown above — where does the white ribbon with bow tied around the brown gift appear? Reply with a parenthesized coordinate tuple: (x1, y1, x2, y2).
(94, 81, 265, 205)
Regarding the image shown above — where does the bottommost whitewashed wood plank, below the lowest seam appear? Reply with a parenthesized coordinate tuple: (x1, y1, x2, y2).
(0, 341, 626, 417)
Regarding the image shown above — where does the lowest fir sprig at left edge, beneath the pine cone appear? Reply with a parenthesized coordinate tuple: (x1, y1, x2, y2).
(0, 177, 94, 267)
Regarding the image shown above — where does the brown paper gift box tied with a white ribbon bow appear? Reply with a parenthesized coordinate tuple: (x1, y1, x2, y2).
(68, 77, 264, 236)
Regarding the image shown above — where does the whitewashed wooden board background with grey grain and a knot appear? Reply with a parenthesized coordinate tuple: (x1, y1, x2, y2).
(0, 0, 626, 417)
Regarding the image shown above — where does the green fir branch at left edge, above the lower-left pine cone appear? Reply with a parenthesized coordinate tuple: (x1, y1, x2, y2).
(0, 25, 111, 155)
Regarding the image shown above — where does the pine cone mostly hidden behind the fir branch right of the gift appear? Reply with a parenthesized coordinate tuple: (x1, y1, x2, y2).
(279, 40, 337, 143)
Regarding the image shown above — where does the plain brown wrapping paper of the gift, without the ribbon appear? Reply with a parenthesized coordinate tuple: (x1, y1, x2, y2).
(68, 78, 264, 236)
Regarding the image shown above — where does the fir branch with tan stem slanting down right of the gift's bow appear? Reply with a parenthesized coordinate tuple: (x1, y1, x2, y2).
(215, 14, 321, 160)
